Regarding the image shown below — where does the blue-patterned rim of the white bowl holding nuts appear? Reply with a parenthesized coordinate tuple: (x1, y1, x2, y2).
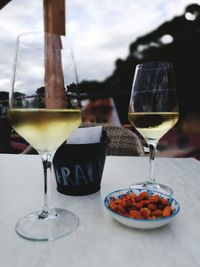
(104, 188, 180, 223)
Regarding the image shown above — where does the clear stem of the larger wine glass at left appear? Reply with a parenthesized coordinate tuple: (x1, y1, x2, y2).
(39, 154, 55, 219)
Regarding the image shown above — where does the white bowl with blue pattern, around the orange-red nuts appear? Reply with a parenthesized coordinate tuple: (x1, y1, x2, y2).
(104, 189, 180, 229)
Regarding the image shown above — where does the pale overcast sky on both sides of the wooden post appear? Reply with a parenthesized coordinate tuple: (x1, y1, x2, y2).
(0, 0, 199, 91)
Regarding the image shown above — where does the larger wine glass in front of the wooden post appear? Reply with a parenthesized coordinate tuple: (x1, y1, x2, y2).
(9, 33, 81, 241)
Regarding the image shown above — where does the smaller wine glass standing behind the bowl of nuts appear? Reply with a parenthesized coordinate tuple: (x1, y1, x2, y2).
(128, 62, 179, 195)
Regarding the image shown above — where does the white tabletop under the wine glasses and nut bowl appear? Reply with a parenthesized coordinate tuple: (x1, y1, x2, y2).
(0, 154, 200, 267)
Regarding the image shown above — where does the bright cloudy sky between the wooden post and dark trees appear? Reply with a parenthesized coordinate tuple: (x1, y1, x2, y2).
(68, 0, 190, 80)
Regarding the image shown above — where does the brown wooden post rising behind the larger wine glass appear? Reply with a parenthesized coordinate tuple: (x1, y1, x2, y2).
(44, 0, 66, 109)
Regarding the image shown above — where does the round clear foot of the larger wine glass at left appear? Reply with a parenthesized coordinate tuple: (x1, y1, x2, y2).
(15, 209, 79, 241)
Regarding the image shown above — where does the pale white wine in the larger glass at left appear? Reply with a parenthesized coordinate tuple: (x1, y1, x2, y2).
(9, 109, 81, 152)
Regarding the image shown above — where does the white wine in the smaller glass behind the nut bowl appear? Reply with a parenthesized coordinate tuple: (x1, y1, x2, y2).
(128, 112, 179, 142)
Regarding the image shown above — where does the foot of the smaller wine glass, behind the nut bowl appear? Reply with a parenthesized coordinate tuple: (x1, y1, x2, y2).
(129, 182, 173, 196)
